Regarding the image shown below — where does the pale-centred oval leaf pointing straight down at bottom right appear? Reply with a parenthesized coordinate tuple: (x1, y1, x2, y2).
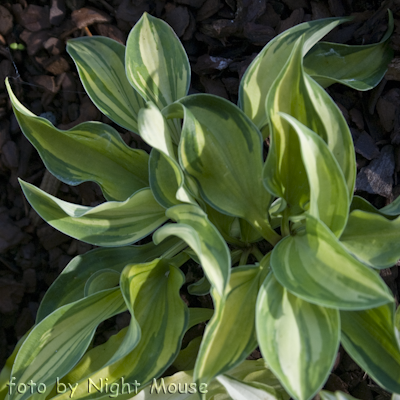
(256, 273, 340, 400)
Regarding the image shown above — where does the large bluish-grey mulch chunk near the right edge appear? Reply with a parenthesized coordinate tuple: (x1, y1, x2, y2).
(356, 145, 395, 198)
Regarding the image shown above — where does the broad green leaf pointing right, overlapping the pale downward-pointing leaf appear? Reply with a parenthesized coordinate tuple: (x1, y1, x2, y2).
(271, 215, 393, 310)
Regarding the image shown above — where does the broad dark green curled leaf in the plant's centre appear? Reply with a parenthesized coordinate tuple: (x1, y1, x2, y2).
(163, 94, 280, 244)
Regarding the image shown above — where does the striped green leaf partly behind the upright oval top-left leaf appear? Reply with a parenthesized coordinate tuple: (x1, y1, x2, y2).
(67, 36, 145, 133)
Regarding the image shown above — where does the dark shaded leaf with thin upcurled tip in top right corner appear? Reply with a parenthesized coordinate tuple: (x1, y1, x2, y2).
(304, 10, 394, 90)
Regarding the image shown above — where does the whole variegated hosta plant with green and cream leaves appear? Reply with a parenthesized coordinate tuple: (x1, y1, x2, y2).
(0, 8, 400, 400)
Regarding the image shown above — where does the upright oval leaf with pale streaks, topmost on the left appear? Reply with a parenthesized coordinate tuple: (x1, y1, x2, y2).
(125, 13, 190, 109)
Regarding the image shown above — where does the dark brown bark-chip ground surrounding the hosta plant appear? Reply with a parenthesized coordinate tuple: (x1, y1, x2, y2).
(0, 0, 400, 400)
